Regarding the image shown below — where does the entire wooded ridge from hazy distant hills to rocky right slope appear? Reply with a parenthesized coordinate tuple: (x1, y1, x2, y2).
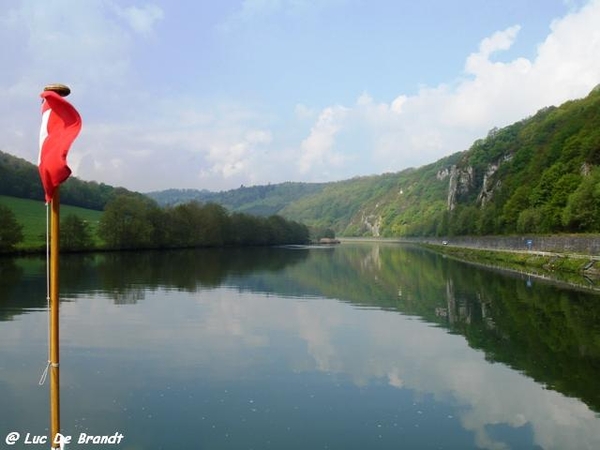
(150, 88, 600, 236)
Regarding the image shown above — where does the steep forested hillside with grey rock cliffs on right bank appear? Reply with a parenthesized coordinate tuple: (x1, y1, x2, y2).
(358, 87, 600, 236)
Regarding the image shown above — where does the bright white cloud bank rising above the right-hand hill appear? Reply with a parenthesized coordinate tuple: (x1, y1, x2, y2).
(300, 0, 600, 177)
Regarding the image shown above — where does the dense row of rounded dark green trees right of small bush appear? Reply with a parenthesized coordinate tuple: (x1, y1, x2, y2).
(98, 194, 309, 249)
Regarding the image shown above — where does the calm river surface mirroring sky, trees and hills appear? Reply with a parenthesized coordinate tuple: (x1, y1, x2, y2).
(0, 244, 600, 450)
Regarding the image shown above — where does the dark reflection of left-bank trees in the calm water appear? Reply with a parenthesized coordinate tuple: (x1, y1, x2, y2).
(0, 247, 308, 314)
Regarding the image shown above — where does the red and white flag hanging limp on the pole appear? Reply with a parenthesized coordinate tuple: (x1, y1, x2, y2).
(38, 91, 81, 203)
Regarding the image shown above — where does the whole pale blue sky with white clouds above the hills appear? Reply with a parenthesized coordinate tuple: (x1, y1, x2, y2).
(0, 0, 600, 192)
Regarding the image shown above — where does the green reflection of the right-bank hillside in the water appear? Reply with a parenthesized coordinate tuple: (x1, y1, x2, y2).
(294, 245, 600, 411)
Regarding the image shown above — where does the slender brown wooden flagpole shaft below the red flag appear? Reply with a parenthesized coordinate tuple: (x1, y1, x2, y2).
(50, 188, 60, 448)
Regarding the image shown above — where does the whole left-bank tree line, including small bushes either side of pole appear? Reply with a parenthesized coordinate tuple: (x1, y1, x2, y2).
(0, 193, 310, 252)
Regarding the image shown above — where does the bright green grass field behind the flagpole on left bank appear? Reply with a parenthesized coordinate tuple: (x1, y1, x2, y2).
(0, 195, 102, 250)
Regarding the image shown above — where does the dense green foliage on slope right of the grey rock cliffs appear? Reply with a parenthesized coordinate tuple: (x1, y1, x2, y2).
(448, 91, 600, 234)
